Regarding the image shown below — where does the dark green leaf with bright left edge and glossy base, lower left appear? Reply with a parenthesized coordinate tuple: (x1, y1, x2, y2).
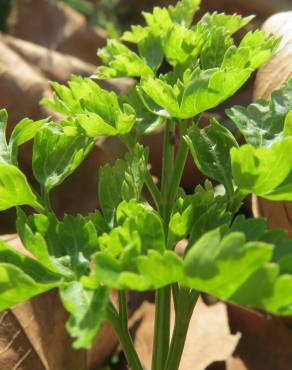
(17, 210, 99, 278)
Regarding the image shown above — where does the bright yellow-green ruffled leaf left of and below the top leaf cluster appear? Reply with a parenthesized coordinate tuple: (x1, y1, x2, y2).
(42, 76, 135, 138)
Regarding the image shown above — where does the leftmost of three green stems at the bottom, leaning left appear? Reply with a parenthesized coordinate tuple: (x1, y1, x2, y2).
(107, 295, 143, 370)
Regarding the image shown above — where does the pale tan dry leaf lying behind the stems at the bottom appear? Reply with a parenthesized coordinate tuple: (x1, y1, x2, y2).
(131, 299, 240, 370)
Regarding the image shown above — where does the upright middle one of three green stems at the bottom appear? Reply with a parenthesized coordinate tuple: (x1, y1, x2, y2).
(152, 286, 170, 370)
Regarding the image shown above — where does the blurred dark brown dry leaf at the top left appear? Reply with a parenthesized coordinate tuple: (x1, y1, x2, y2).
(8, 0, 106, 64)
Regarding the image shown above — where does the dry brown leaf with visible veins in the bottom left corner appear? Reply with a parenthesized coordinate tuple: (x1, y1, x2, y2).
(0, 235, 117, 370)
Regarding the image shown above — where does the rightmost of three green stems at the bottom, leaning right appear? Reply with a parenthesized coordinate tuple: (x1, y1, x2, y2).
(164, 288, 199, 370)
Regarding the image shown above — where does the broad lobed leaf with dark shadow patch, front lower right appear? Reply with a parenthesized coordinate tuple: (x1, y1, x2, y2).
(184, 228, 272, 299)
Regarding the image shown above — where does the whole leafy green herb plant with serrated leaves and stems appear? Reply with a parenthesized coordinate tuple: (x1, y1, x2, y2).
(0, 0, 292, 370)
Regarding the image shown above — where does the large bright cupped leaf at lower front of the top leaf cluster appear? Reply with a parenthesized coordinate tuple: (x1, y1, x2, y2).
(141, 68, 252, 119)
